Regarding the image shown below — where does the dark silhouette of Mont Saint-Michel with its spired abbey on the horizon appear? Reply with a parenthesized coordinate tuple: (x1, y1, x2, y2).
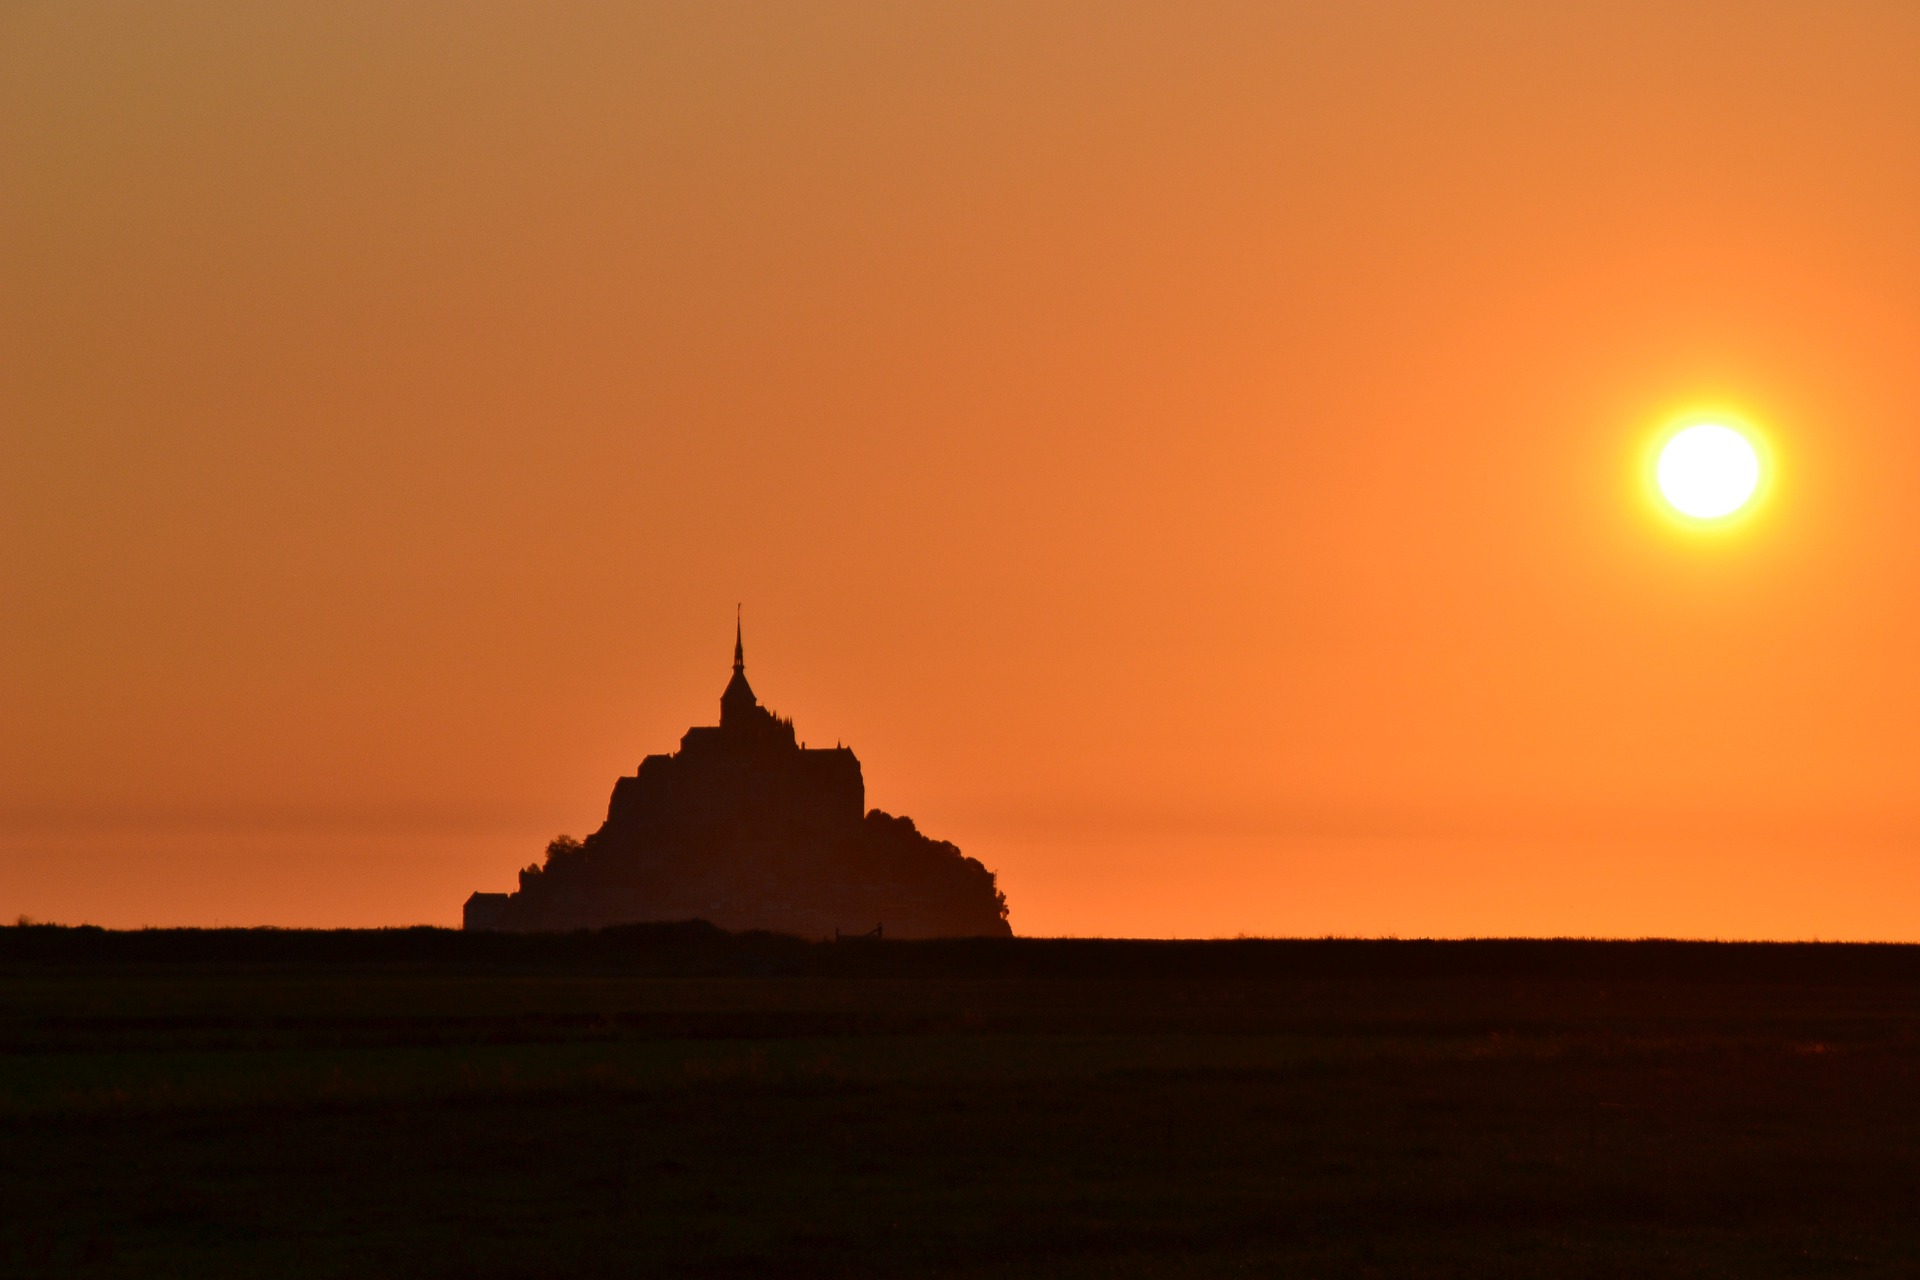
(465, 622, 1012, 938)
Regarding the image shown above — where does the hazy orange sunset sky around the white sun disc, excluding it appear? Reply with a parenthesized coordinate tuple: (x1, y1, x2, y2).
(0, 0, 1920, 938)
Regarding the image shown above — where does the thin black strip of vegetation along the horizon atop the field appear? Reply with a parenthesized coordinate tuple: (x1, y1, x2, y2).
(0, 921, 1920, 984)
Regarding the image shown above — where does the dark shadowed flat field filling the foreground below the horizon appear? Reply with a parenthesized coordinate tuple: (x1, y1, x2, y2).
(0, 927, 1920, 1278)
